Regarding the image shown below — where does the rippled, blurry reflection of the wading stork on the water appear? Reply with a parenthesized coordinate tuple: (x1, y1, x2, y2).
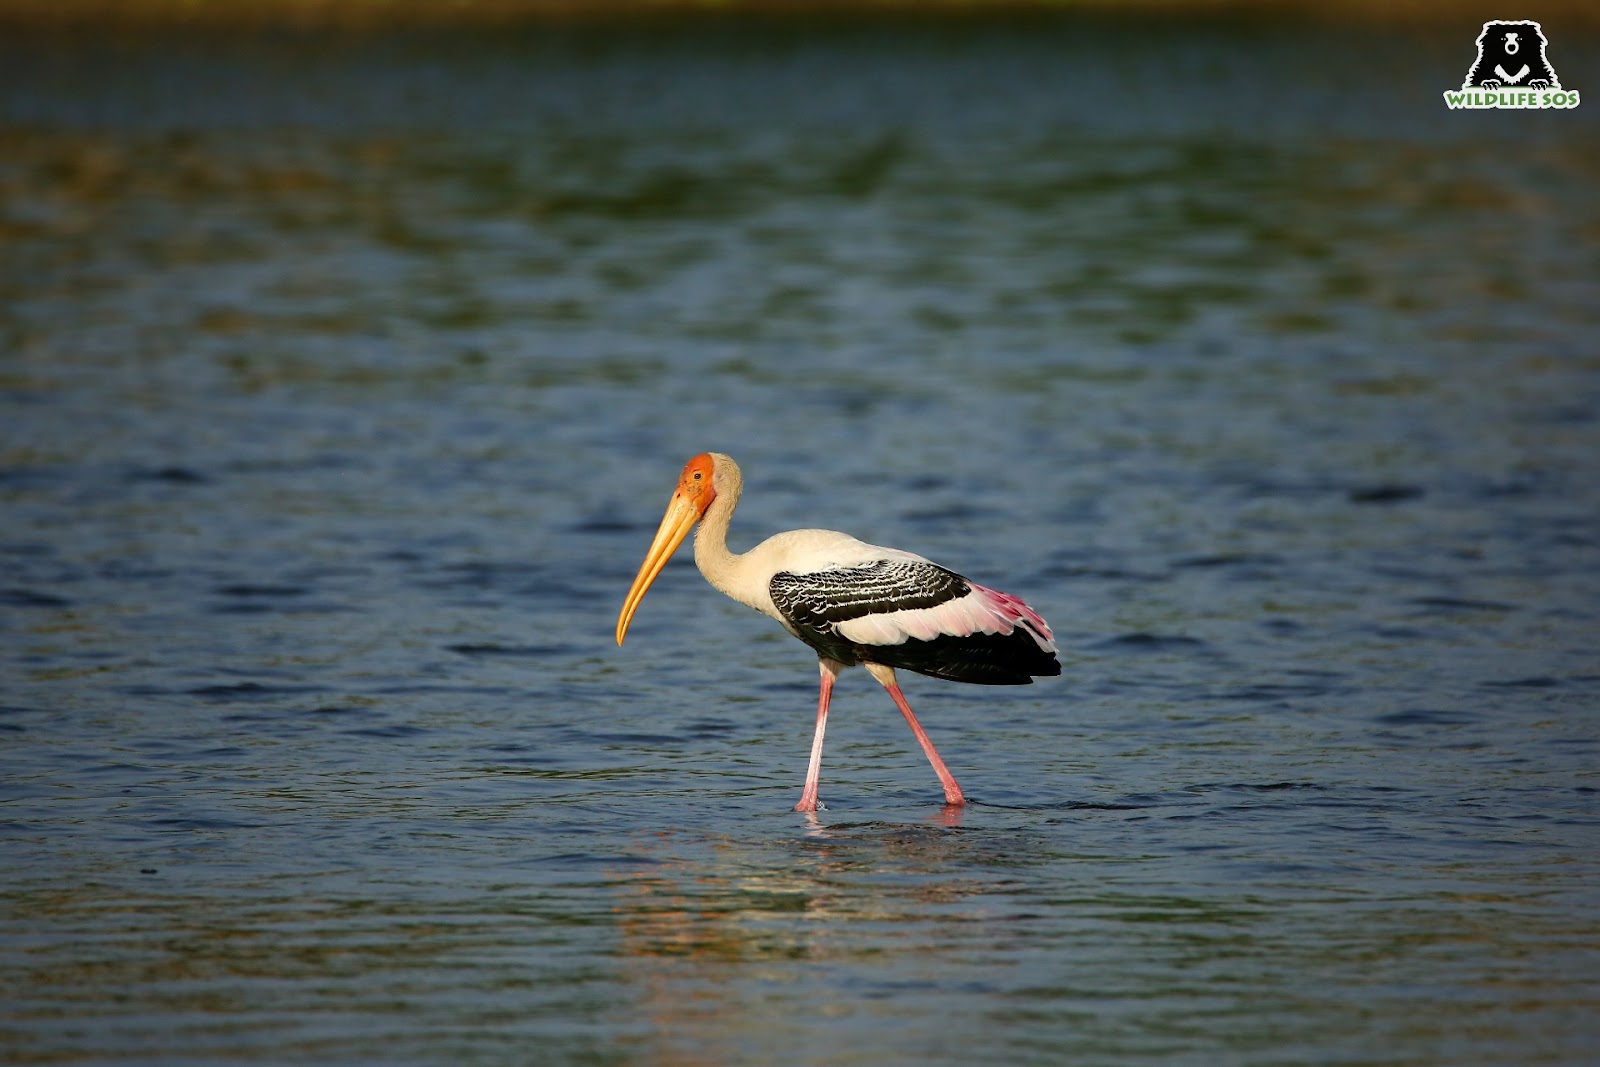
(613, 805, 995, 1064)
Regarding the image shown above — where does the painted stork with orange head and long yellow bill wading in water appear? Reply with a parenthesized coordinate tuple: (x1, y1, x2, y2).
(616, 453, 1061, 811)
